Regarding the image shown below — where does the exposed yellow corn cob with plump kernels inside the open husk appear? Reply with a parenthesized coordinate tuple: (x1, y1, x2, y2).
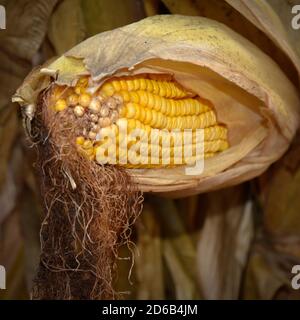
(50, 75, 229, 168)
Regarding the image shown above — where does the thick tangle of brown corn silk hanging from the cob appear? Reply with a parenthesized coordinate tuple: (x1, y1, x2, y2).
(32, 88, 143, 299)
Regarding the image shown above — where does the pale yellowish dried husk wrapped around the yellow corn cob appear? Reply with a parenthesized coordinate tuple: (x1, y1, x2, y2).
(14, 15, 300, 196)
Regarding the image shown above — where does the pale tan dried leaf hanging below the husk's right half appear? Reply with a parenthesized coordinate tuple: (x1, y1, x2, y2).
(197, 185, 253, 299)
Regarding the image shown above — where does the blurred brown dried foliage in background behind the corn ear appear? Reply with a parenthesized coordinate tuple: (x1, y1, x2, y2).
(0, 0, 300, 299)
